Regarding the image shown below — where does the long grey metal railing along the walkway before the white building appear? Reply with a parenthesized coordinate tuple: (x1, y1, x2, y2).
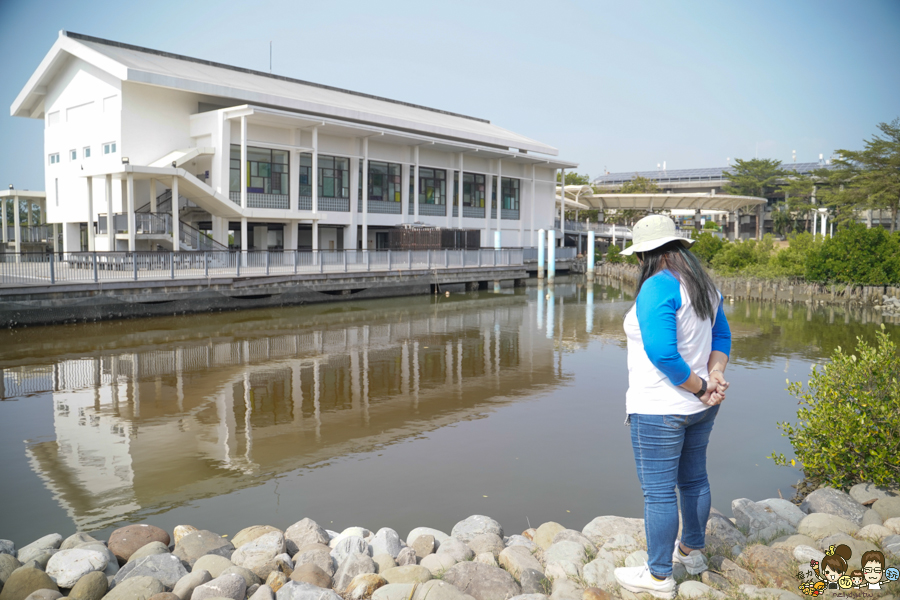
(0, 248, 524, 286)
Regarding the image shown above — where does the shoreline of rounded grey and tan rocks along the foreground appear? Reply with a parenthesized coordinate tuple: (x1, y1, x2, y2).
(0, 484, 900, 600)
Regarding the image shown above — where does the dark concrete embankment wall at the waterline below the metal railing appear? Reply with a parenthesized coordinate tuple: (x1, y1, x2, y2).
(0, 266, 528, 327)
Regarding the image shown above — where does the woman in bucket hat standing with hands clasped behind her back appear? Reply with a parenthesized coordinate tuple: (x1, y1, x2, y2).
(615, 215, 731, 598)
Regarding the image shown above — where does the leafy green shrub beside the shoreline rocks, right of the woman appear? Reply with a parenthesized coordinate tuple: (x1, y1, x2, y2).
(771, 325, 900, 489)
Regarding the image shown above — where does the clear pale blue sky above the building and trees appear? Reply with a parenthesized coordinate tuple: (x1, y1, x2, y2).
(0, 0, 900, 189)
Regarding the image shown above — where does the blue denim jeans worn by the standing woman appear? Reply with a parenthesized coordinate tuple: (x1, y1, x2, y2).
(630, 406, 719, 577)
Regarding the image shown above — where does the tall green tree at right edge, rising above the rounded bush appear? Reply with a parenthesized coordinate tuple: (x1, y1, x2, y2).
(834, 118, 900, 233)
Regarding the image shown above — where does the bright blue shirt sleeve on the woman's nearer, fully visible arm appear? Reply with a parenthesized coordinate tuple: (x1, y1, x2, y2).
(635, 273, 688, 385)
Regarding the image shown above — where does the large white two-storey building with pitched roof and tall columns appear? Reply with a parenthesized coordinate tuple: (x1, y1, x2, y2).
(11, 31, 577, 251)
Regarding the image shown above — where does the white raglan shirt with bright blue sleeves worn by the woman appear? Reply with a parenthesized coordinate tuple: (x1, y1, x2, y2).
(625, 269, 731, 415)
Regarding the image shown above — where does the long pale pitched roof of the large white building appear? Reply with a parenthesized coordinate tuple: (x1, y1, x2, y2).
(10, 31, 558, 156)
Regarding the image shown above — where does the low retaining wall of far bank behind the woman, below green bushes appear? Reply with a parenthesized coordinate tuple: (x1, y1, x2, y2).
(596, 264, 900, 306)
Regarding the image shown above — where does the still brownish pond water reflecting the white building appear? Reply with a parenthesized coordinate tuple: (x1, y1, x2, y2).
(0, 280, 896, 546)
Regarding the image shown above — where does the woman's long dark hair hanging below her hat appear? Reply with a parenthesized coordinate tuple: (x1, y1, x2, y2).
(636, 240, 719, 321)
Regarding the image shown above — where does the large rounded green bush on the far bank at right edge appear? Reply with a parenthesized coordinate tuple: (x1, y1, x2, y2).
(805, 224, 900, 285)
